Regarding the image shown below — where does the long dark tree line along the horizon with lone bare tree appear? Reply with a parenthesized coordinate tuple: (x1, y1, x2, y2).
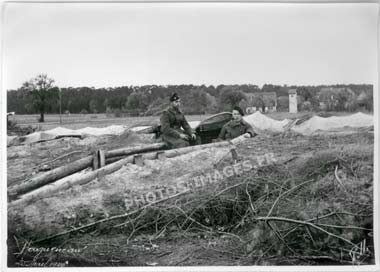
(7, 74, 373, 121)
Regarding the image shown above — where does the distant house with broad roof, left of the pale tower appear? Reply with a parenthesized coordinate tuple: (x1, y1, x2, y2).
(245, 92, 277, 113)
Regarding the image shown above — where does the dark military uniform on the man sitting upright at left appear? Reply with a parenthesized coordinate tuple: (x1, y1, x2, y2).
(160, 106, 193, 148)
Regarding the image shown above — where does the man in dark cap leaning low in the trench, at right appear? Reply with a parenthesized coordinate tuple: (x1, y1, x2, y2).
(218, 106, 257, 140)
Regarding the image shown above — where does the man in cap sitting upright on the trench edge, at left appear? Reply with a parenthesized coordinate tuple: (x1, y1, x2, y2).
(160, 93, 197, 148)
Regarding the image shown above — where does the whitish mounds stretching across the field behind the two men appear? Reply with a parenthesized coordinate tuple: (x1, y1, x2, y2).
(7, 112, 373, 145)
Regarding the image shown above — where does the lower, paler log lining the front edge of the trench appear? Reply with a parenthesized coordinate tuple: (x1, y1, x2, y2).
(10, 141, 235, 207)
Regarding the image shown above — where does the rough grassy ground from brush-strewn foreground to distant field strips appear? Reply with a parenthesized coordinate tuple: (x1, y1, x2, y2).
(7, 113, 374, 267)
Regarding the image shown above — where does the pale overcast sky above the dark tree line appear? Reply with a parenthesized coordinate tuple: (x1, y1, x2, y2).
(2, 3, 379, 90)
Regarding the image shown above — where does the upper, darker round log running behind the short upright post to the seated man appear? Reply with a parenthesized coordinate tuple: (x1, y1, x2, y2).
(8, 143, 166, 198)
